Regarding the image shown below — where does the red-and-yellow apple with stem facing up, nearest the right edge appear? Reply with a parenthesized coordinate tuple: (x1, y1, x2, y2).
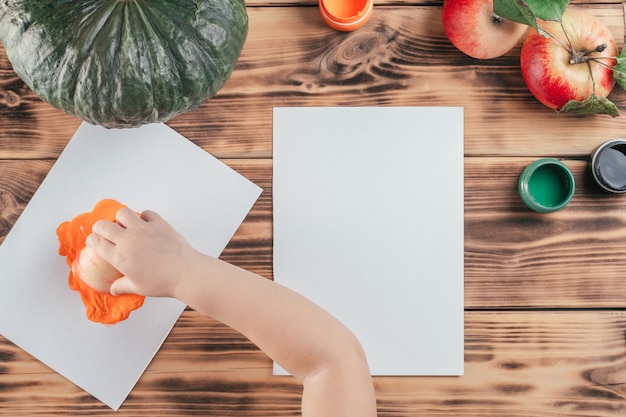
(520, 8, 618, 110)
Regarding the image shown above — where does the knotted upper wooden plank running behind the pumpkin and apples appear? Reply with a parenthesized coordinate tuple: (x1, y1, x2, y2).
(0, 3, 626, 158)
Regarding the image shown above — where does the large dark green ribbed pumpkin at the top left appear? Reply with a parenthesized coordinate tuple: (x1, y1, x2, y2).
(0, 0, 248, 128)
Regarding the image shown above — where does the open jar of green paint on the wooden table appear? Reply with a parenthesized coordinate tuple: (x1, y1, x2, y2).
(518, 158, 576, 213)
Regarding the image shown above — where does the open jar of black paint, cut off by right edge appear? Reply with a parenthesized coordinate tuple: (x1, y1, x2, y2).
(591, 139, 626, 193)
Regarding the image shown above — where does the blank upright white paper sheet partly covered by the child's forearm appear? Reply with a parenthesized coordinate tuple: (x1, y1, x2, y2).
(273, 107, 464, 375)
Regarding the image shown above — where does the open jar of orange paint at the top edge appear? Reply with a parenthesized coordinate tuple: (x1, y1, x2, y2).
(318, 0, 374, 32)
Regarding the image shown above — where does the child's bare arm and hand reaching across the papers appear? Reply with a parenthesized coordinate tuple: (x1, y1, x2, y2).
(87, 209, 376, 417)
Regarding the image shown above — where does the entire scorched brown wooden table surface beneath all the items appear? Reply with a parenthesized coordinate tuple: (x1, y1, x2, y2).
(0, 0, 626, 417)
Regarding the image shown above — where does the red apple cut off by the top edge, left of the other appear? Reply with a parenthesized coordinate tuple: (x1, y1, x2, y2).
(442, 0, 528, 59)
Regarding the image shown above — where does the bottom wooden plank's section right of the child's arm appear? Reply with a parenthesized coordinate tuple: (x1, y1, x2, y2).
(377, 312, 626, 417)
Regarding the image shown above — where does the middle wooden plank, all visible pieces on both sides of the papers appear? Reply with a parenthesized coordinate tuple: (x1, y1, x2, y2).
(0, 158, 626, 308)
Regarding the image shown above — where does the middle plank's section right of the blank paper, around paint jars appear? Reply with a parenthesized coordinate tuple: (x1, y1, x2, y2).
(465, 158, 626, 308)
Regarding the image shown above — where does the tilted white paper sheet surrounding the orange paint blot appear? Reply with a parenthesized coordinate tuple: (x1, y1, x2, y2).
(0, 123, 261, 409)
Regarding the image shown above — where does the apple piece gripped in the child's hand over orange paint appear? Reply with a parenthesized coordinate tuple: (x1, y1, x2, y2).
(72, 246, 122, 293)
